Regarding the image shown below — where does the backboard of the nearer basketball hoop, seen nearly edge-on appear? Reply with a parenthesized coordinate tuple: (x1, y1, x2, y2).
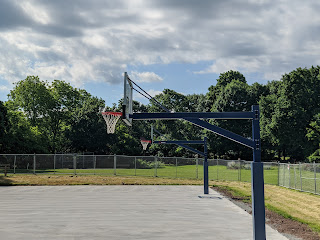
(122, 72, 133, 126)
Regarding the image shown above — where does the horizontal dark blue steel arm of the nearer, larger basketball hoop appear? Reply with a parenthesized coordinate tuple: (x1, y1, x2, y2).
(130, 112, 254, 120)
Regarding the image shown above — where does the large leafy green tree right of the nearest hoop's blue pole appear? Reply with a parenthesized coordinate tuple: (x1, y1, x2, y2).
(260, 66, 320, 160)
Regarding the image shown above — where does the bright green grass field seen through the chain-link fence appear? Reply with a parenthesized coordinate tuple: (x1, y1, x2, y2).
(3, 164, 320, 194)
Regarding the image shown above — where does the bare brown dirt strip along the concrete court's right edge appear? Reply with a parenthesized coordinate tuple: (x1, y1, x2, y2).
(212, 187, 320, 240)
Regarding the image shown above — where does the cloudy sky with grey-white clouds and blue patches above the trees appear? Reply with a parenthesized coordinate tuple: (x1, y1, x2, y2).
(0, 0, 320, 106)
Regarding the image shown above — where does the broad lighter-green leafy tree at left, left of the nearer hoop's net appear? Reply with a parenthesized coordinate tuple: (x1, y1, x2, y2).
(9, 76, 104, 153)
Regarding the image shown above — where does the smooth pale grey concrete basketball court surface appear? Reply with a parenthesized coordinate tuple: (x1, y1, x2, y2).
(0, 186, 287, 240)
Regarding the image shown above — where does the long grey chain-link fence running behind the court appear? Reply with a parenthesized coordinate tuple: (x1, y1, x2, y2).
(0, 154, 320, 194)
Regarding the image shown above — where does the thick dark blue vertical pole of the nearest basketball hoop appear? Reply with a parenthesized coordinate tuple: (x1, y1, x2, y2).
(251, 105, 266, 240)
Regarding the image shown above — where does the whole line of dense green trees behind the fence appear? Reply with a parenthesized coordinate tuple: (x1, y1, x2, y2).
(0, 66, 320, 162)
